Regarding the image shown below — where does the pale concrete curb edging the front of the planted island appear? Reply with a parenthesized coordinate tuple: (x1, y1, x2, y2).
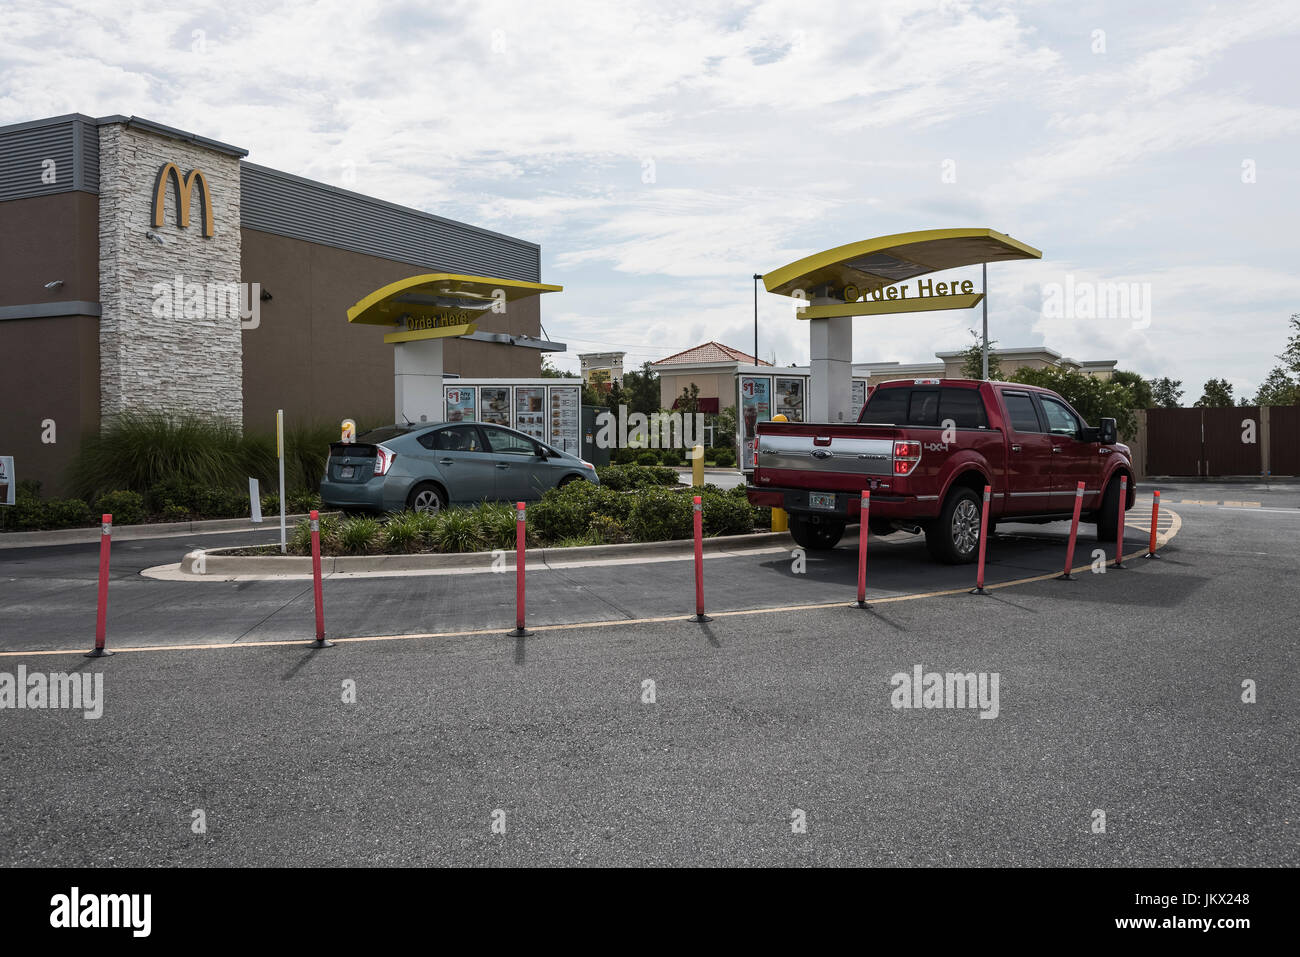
(179, 532, 792, 577)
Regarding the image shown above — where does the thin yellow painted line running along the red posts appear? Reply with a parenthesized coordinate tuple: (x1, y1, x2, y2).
(0, 510, 1183, 658)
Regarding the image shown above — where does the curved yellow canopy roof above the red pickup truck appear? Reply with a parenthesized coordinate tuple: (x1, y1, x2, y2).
(763, 228, 1043, 295)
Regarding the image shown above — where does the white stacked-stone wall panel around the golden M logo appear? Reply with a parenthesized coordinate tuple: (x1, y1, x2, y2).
(99, 124, 243, 426)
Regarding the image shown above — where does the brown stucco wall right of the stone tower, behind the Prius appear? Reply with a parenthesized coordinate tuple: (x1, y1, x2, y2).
(243, 229, 543, 432)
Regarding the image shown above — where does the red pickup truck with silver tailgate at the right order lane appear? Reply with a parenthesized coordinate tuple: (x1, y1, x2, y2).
(746, 378, 1136, 564)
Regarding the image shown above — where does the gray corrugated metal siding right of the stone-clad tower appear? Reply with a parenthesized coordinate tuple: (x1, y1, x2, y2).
(239, 163, 541, 282)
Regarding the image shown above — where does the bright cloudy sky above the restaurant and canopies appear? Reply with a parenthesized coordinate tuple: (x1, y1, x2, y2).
(0, 0, 1300, 403)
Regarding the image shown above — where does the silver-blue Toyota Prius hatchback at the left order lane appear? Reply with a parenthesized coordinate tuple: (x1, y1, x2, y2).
(321, 423, 599, 512)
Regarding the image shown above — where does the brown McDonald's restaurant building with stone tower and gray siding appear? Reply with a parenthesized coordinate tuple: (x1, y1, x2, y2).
(0, 114, 564, 494)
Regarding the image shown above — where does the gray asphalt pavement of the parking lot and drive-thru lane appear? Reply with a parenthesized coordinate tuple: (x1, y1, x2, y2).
(0, 485, 1300, 866)
